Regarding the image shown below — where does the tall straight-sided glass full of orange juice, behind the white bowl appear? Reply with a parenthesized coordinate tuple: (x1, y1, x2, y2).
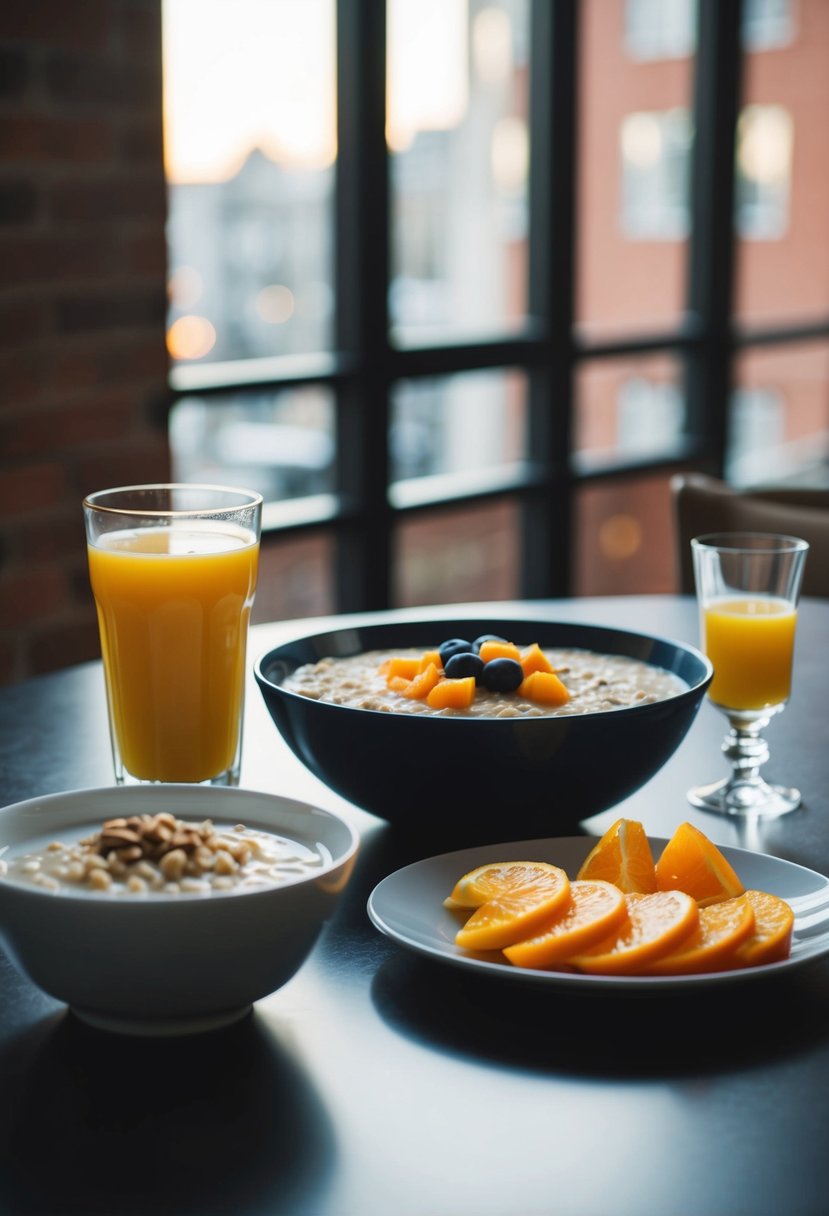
(83, 484, 263, 786)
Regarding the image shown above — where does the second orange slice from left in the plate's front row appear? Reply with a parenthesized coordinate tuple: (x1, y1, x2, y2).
(504, 882, 627, 967)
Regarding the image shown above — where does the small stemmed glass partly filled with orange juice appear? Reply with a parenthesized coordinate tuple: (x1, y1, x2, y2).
(688, 533, 808, 817)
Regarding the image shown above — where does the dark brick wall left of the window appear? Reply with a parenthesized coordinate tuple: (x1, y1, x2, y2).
(0, 0, 169, 683)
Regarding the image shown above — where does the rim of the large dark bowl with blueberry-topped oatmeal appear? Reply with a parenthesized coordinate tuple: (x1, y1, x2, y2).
(253, 615, 714, 728)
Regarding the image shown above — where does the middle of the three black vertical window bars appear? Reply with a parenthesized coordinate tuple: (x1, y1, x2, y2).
(521, 0, 577, 597)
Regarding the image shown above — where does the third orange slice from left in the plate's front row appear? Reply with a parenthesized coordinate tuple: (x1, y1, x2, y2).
(569, 891, 699, 975)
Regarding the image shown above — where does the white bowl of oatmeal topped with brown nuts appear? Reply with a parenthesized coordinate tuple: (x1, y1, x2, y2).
(0, 784, 357, 1035)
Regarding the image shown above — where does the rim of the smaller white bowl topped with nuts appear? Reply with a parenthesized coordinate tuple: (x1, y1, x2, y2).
(0, 782, 360, 909)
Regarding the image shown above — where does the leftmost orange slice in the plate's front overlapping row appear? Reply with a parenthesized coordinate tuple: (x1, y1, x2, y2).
(455, 862, 570, 950)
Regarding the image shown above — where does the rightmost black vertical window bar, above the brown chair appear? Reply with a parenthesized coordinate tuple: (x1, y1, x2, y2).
(686, 0, 743, 475)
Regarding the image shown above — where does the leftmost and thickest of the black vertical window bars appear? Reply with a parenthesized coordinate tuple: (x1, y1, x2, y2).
(335, 0, 393, 612)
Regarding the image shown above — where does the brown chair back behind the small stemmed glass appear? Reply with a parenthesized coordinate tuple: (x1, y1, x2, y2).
(671, 473, 829, 597)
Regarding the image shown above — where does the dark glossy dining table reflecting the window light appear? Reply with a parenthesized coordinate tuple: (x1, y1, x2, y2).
(0, 595, 829, 1216)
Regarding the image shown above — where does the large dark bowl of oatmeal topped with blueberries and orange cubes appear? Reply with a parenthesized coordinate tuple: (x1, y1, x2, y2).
(254, 613, 712, 844)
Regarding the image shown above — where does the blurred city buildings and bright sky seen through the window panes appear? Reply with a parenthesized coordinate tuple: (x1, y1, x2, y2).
(164, 0, 829, 608)
